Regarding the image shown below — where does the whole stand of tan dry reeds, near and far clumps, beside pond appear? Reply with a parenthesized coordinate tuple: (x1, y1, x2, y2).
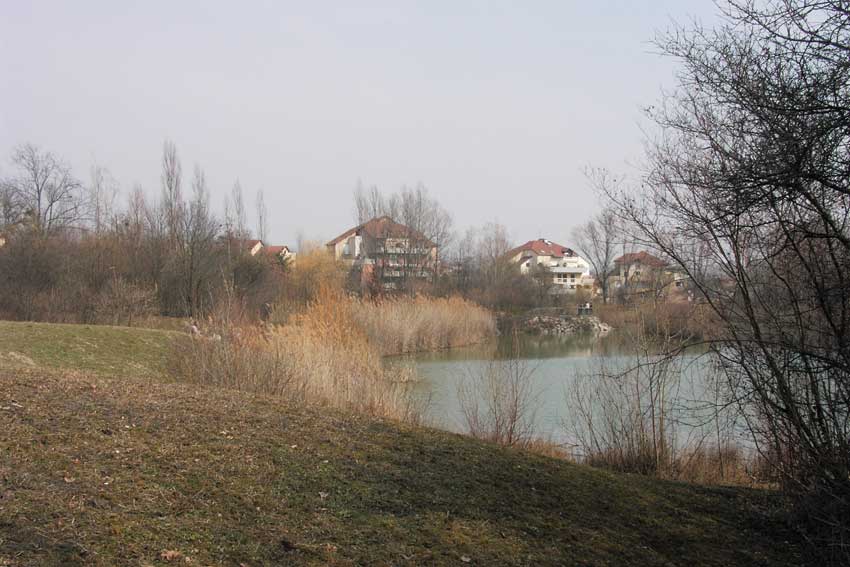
(172, 288, 495, 422)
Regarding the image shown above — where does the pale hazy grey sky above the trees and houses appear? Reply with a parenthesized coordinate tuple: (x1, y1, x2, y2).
(0, 0, 716, 245)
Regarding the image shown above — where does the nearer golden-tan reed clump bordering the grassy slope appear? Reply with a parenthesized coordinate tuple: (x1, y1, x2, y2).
(171, 288, 424, 422)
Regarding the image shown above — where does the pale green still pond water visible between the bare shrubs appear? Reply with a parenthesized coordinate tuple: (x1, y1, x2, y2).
(399, 333, 714, 443)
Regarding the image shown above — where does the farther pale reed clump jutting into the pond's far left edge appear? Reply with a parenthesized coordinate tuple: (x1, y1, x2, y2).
(352, 296, 496, 355)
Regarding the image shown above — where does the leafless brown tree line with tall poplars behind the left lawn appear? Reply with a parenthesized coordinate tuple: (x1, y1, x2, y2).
(0, 142, 285, 324)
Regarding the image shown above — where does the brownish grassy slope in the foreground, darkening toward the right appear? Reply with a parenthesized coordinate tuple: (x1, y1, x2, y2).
(0, 326, 799, 566)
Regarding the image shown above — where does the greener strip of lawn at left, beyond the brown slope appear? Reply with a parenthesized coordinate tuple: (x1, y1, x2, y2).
(0, 321, 175, 377)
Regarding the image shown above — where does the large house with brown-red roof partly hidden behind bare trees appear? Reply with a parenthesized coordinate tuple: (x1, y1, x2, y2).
(326, 216, 438, 290)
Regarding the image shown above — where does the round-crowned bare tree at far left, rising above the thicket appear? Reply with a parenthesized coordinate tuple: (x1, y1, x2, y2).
(3, 144, 84, 236)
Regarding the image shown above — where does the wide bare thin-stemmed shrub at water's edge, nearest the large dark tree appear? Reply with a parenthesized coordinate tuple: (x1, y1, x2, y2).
(565, 334, 748, 484)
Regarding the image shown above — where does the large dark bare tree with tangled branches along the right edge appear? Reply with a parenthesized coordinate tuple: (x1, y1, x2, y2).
(611, 0, 850, 561)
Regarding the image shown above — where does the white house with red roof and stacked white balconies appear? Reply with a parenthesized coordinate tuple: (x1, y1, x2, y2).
(506, 238, 593, 294)
